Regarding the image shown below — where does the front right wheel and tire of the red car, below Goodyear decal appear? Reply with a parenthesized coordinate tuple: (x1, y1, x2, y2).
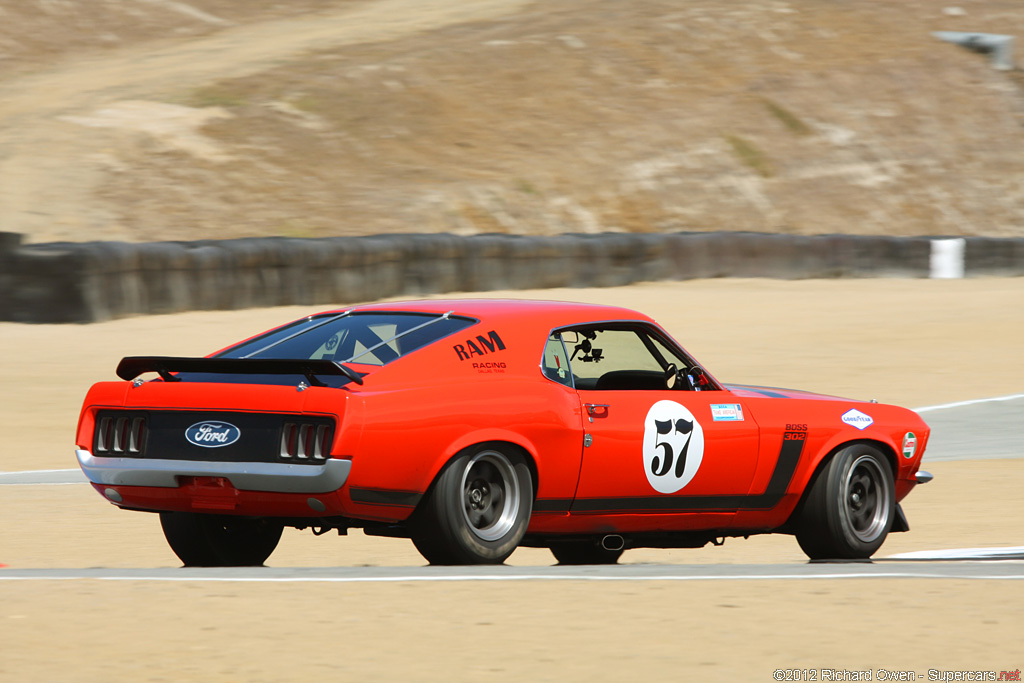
(796, 443, 896, 560)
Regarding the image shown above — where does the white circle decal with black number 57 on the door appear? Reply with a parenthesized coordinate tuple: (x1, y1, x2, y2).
(643, 400, 703, 494)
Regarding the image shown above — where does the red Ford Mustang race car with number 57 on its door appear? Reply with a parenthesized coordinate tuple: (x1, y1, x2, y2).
(77, 300, 931, 565)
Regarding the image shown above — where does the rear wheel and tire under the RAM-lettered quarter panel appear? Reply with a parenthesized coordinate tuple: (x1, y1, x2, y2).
(410, 444, 534, 564)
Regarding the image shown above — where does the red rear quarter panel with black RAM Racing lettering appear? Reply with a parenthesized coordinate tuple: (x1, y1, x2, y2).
(339, 317, 583, 520)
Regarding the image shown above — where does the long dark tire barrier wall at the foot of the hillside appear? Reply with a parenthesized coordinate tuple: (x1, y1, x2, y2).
(0, 232, 1024, 323)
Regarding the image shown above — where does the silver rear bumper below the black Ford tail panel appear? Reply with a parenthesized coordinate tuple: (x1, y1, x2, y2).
(75, 450, 352, 494)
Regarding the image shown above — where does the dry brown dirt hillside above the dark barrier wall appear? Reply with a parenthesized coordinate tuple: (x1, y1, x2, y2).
(0, 0, 1024, 242)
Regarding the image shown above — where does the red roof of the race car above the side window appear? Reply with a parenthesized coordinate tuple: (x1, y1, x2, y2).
(321, 299, 653, 329)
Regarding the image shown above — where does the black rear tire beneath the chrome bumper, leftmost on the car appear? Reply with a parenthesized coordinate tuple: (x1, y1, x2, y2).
(160, 512, 284, 567)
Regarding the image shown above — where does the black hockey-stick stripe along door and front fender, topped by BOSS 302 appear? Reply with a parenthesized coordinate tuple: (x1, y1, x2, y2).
(572, 432, 807, 513)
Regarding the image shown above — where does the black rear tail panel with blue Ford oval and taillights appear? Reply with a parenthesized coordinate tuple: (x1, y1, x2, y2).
(93, 410, 334, 465)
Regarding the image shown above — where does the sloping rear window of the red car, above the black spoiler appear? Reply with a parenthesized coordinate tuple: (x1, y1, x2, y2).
(218, 311, 476, 366)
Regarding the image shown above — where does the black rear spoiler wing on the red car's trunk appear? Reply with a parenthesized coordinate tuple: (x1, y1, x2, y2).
(117, 355, 362, 386)
